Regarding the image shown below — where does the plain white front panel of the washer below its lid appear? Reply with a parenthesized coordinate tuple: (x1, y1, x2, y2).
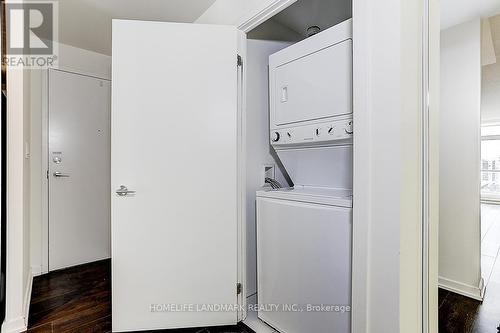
(257, 197, 352, 333)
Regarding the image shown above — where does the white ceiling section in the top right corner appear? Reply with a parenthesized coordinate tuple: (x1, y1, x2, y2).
(441, 0, 500, 29)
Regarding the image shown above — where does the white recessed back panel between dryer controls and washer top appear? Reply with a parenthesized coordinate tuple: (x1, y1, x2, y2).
(276, 145, 353, 189)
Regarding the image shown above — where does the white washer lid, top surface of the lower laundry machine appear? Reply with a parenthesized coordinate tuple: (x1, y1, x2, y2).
(257, 186, 352, 208)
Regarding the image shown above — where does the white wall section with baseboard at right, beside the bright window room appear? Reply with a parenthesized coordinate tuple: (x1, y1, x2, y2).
(439, 19, 482, 298)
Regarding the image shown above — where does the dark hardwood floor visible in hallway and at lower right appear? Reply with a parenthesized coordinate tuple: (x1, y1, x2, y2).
(28, 260, 500, 333)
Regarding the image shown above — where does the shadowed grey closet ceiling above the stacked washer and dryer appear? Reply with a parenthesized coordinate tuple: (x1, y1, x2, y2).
(273, 0, 352, 37)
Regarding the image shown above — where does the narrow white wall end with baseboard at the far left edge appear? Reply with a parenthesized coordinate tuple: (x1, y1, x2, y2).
(1, 67, 31, 333)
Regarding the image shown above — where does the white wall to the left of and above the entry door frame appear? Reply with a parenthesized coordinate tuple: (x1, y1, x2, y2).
(30, 44, 111, 275)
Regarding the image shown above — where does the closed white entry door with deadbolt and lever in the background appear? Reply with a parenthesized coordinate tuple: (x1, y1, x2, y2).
(48, 70, 111, 270)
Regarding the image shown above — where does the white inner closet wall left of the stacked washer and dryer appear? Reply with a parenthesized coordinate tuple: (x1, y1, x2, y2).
(246, 40, 290, 296)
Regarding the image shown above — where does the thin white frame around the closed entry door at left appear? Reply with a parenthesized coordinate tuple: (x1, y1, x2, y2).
(40, 68, 111, 274)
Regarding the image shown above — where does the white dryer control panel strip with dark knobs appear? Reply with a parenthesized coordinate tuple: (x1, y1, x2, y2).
(270, 119, 354, 148)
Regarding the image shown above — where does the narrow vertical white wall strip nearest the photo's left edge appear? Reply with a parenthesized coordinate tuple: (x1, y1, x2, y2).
(2, 68, 32, 333)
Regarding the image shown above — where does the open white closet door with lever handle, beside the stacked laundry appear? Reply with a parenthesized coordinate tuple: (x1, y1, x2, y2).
(111, 20, 243, 331)
